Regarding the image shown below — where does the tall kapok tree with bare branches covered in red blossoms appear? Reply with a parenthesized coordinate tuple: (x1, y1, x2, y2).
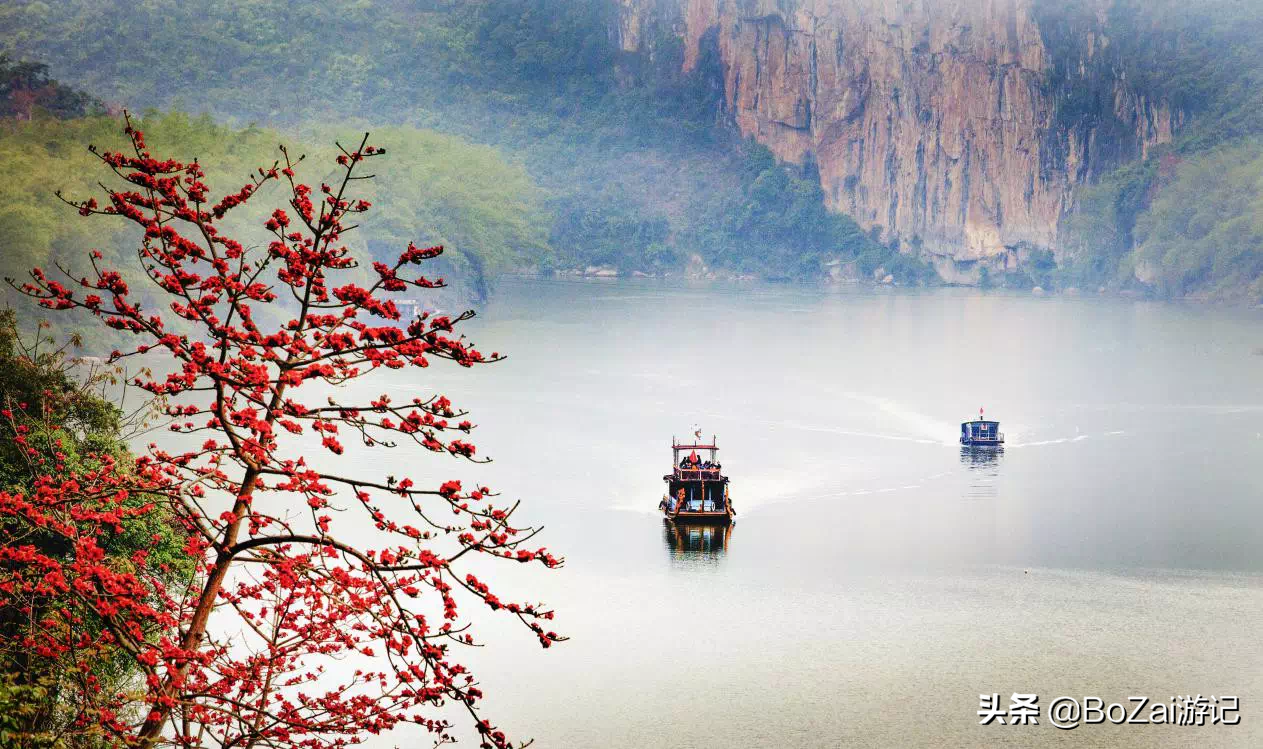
(0, 113, 563, 748)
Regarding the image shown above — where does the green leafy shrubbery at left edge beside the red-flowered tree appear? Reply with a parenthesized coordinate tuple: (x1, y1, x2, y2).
(0, 309, 193, 749)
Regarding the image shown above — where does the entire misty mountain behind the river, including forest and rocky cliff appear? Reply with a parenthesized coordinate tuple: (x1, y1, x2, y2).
(0, 0, 1263, 299)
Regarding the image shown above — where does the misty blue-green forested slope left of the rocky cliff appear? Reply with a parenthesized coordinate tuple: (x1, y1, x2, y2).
(0, 0, 932, 291)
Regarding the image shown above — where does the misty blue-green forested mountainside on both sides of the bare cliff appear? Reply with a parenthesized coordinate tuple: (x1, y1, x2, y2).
(0, 0, 1263, 299)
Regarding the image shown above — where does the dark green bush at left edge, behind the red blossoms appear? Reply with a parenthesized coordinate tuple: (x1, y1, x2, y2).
(0, 309, 192, 748)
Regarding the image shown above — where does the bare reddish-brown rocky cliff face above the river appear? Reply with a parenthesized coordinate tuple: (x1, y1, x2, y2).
(619, 0, 1181, 282)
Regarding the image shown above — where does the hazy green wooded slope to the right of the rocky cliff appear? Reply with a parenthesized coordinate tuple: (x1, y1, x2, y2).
(1041, 0, 1263, 302)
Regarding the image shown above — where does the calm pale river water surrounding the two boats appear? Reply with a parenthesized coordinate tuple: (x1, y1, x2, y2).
(343, 280, 1263, 748)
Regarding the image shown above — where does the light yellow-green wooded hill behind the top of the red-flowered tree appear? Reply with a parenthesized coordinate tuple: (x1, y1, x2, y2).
(0, 107, 548, 306)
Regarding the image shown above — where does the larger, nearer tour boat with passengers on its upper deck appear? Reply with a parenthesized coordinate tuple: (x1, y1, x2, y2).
(658, 431, 736, 525)
